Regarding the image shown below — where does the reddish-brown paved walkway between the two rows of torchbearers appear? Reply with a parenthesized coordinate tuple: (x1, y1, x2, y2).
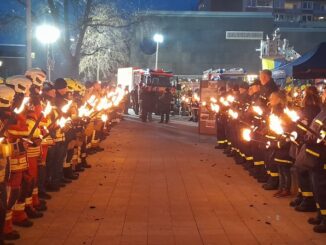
(16, 119, 326, 245)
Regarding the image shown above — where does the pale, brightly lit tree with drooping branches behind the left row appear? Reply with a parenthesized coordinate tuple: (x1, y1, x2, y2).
(79, 4, 130, 79)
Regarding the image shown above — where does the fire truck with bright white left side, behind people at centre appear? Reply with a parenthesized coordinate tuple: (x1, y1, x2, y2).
(118, 67, 173, 115)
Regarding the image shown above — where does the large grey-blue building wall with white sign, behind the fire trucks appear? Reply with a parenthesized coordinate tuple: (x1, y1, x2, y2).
(130, 11, 326, 75)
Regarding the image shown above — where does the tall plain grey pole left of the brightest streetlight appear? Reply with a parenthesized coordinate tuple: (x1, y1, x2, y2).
(26, 0, 32, 70)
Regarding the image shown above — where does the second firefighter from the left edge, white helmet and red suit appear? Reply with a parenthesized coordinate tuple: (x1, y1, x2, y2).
(4, 76, 35, 236)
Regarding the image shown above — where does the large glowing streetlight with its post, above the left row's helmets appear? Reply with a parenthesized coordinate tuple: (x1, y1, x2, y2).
(36, 24, 60, 81)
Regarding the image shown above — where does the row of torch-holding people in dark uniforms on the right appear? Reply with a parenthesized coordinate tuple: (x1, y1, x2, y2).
(211, 70, 326, 233)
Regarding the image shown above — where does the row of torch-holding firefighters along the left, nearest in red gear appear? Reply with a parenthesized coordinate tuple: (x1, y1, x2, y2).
(0, 68, 124, 244)
